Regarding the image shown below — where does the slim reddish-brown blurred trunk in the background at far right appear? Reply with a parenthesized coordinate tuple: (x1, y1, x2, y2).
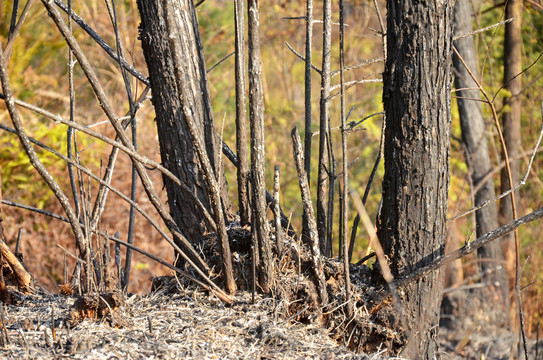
(499, 0, 523, 276)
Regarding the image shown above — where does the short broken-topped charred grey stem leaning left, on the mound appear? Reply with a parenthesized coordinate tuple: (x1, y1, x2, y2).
(291, 127, 328, 306)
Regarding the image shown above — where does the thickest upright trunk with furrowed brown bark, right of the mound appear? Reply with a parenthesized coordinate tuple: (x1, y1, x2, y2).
(378, 0, 453, 359)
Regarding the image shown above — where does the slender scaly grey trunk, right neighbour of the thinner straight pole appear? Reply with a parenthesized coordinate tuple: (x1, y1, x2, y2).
(248, 0, 273, 293)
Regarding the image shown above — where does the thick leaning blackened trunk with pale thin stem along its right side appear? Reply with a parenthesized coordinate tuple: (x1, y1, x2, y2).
(138, 0, 235, 292)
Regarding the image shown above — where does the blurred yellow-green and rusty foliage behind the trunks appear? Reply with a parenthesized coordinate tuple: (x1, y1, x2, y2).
(0, 0, 543, 334)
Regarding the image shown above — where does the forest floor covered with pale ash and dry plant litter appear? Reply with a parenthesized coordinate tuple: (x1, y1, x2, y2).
(0, 287, 543, 360)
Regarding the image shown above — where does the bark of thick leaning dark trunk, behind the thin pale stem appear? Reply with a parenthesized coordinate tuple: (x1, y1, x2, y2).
(138, 0, 226, 242)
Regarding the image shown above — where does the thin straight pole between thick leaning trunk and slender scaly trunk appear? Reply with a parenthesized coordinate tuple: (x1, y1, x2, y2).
(234, 0, 250, 226)
